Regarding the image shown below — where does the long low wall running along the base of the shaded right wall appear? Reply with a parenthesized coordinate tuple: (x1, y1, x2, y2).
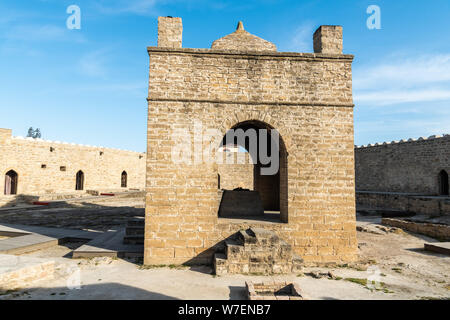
(356, 191, 450, 216)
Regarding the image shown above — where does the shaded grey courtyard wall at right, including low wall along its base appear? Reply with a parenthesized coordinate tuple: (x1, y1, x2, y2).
(355, 135, 450, 215)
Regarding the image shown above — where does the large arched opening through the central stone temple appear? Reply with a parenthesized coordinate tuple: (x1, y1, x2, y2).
(218, 120, 288, 222)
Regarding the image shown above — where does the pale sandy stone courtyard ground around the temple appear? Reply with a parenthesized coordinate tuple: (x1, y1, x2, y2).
(0, 199, 450, 300)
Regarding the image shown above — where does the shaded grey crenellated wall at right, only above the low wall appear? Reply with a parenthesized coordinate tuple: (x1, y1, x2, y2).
(355, 135, 450, 195)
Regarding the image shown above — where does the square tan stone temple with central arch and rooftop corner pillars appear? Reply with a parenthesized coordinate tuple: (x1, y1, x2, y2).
(144, 17, 357, 264)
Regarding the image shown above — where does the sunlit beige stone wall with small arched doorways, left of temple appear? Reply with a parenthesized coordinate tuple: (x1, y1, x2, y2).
(0, 129, 146, 205)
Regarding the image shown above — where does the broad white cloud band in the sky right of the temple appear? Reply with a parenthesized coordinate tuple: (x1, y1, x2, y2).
(353, 54, 450, 105)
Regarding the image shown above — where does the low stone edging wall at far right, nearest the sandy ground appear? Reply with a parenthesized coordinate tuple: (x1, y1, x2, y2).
(381, 218, 450, 241)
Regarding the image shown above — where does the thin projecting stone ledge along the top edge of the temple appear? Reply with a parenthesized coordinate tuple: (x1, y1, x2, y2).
(147, 47, 354, 61)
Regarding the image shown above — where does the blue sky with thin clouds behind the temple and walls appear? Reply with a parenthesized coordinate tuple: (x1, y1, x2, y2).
(0, 0, 450, 151)
